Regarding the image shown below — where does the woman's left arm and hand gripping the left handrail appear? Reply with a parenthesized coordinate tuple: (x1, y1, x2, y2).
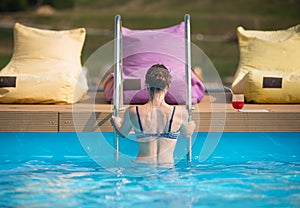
(110, 108, 132, 138)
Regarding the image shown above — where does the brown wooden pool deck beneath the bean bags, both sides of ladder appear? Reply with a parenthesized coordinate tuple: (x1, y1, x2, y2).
(0, 93, 300, 132)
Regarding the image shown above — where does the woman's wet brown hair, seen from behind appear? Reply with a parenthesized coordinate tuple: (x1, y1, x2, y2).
(145, 64, 172, 100)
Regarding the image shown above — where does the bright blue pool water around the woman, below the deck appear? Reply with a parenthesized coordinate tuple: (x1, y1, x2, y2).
(0, 133, 300, 207)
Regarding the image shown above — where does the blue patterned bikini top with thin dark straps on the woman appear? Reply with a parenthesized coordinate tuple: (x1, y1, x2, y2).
(135, 106, 180, 139)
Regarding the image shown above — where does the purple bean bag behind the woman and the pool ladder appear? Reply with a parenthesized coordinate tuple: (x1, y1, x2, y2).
(104, 22, 205, 104)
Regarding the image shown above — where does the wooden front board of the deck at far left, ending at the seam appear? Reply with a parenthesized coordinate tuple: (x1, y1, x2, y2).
(0, 111, 58, 132)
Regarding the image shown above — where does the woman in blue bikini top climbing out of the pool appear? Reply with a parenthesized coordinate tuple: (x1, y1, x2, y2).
(111, 64, 196, 164)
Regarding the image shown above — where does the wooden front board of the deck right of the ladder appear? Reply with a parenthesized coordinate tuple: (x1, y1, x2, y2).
(193, 112, 300, 132)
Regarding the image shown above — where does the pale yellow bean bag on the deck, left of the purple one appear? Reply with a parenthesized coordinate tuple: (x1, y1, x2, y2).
(0, 23, 88, 103)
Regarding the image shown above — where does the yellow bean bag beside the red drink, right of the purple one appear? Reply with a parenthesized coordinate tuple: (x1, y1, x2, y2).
(232, 25, 300, 103)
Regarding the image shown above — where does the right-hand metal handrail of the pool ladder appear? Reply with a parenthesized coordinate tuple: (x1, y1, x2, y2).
(184, 14, 192, 162)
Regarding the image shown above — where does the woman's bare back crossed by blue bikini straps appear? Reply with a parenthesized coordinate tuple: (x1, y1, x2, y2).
(130, 102, 182, 163)
